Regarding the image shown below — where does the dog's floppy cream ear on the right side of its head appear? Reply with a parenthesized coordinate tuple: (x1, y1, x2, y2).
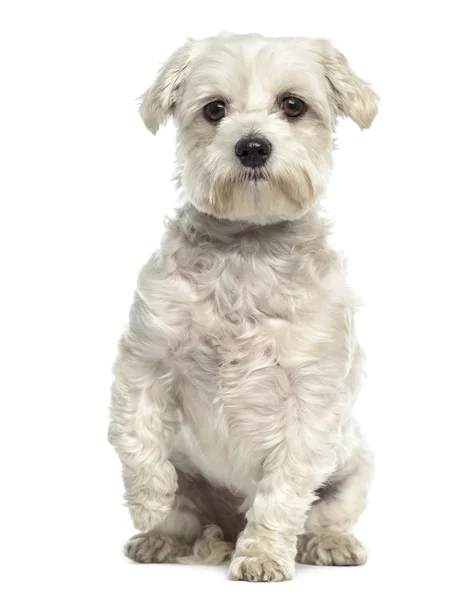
(321, 40, 379, 129)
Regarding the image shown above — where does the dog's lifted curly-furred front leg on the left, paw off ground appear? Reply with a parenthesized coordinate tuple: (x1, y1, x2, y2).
(109, 344, 177, 532)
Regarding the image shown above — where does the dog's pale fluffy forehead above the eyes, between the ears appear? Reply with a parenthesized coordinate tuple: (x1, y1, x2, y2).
(188, 37, 324, 110)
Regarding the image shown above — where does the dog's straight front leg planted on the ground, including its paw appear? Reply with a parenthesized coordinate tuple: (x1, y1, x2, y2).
(229, 400, 339, 581)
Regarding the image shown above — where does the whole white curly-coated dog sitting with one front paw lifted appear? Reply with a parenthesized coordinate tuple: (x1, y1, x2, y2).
(109, 34, 378, 581)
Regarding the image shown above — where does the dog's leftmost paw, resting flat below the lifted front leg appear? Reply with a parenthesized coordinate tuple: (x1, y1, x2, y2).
(124, 533, 191, 563)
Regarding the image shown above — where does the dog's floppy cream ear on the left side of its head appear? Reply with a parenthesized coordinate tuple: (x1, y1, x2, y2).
(139, 40, 194, 134)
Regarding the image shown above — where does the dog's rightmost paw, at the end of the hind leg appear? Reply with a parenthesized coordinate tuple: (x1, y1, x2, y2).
(297, 532, 367, 567)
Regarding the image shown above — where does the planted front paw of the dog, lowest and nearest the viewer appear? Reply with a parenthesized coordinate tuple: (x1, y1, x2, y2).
(229, 554, 295, 581)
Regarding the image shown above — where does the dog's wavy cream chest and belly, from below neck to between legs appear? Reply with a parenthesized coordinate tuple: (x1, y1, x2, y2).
(170, 238, 334, 472)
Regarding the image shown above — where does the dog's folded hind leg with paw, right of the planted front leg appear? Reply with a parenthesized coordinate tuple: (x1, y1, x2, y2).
(296, 440, 372, 566)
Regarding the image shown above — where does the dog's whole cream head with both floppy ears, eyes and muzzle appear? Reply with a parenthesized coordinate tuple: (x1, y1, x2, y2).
(140, 35, 377, 223)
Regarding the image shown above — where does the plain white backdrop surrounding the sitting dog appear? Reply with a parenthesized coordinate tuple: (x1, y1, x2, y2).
(0, 0, 464, 600)
